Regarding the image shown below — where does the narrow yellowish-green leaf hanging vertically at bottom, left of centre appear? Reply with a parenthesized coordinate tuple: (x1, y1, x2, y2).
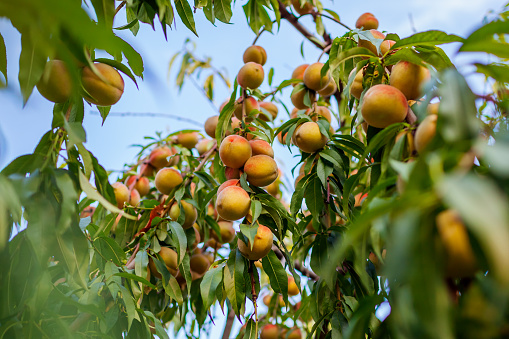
(223, 249, 246, 317)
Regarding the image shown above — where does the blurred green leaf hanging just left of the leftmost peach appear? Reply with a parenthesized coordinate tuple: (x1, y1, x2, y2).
(18, 33, 47, 104)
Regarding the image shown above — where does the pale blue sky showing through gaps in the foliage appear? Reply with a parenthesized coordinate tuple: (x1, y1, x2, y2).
(0, 0, 507, 338)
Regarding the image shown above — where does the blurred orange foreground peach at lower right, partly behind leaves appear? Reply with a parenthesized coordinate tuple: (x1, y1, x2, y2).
(436, 210, 478, 278)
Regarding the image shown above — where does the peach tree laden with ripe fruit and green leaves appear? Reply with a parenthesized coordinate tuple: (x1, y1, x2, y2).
(0, 0, 509, 339)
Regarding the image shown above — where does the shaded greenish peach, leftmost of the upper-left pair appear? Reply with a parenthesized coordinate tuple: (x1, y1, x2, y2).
(36, 60, 73, 103)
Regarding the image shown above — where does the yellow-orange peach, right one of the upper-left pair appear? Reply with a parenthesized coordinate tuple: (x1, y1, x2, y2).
(81, 63, 124, 106)
